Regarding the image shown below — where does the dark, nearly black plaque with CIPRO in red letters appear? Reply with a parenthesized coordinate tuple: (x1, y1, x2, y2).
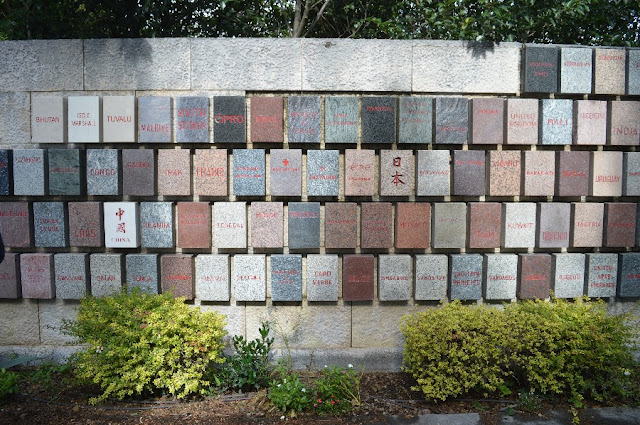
(213, 96, 247, 143)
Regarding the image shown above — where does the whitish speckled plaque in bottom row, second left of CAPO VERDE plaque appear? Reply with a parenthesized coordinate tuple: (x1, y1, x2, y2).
(231, 254, 267, 302)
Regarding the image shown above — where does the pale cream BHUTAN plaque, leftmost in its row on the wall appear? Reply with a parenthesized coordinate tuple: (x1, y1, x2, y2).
(31, 96, 66, 143)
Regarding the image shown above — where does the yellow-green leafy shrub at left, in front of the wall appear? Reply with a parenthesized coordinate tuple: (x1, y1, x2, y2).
(63, 290, 226, 403)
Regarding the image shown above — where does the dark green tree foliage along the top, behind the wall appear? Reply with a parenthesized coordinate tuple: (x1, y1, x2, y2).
(0, 0, 640, 46)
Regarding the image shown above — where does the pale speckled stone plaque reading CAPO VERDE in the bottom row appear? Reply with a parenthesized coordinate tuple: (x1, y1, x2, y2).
(307, 254, 340, 302)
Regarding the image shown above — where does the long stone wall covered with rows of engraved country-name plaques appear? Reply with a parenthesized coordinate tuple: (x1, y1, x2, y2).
(0, 39, 640, 369)
